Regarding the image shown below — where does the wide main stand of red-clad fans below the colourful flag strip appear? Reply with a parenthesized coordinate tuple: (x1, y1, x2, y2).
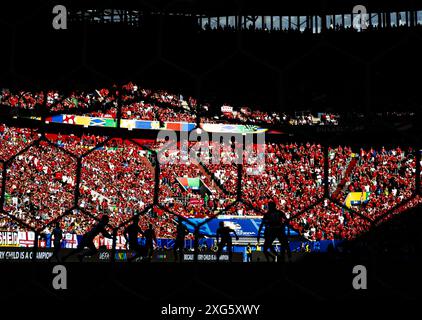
(0, 125, 421, 240)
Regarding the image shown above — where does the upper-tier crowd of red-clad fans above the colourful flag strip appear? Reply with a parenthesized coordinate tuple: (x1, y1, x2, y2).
(0, 82, 346, 125)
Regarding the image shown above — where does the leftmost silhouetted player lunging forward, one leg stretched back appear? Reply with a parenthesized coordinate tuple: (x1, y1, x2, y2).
(63, 215, 113, 262)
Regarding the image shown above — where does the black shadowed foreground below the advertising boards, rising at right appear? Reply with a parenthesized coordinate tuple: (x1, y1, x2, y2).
(0, 207, 422, 304)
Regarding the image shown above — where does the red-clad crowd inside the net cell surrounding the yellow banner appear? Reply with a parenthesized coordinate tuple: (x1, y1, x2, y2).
(331, 147, 416, 219)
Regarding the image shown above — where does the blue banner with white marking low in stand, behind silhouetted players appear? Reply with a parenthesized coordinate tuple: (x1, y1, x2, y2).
(186, 216, 298, 238)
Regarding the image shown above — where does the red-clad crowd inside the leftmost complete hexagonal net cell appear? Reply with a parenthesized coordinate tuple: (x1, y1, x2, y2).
(4, 141, 76, 228)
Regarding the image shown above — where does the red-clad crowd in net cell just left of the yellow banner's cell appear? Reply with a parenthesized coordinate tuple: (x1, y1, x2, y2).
(242, 143, 324, 214)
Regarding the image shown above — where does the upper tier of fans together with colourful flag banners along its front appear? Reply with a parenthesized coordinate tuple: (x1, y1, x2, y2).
(0, 83, 415, 131)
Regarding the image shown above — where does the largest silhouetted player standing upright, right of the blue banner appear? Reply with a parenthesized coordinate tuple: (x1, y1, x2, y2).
(258, 202, 292, 262)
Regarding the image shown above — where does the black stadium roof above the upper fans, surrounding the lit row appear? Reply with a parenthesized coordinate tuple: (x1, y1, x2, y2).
(0, 0, 422, 124)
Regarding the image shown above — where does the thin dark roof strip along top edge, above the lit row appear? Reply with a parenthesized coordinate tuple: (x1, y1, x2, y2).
(0, 0, 421, 21)
